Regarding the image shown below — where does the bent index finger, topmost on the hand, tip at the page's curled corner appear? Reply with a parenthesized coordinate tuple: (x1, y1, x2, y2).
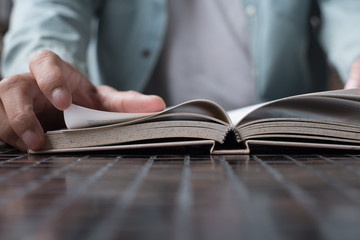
(29, 50, 72, 110)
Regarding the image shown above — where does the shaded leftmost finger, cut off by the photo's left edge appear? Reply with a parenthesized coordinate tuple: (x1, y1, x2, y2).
(0, 101, 27, 151)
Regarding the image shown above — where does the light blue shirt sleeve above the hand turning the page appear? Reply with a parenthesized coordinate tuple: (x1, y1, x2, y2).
(2, 0, 92, 76)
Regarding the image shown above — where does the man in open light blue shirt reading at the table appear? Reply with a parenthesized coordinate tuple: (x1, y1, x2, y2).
(0, 0, 360, 149)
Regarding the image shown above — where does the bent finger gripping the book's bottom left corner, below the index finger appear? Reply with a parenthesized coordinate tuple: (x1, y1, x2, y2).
(0, 74, 44, 150)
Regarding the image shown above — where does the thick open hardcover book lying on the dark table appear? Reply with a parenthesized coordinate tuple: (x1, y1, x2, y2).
(31, 89, 360, 154)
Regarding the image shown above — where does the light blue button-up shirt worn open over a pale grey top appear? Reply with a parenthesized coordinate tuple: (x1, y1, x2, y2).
(2, 0, 360, 100)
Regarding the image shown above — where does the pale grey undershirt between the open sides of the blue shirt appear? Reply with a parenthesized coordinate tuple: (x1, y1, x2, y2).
(145, 0, 258, 110)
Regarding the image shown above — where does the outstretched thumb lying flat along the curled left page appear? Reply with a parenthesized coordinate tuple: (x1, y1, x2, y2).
(97, 86, 165, 112)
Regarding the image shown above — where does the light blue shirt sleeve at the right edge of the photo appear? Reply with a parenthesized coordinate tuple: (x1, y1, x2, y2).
(319, 0, 360, 82)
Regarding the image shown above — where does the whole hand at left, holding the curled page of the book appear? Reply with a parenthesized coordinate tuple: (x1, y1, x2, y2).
(0, 50, 165, 151)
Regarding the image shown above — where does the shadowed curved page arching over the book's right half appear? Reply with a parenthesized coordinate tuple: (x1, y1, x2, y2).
(237, 89, 360, 126)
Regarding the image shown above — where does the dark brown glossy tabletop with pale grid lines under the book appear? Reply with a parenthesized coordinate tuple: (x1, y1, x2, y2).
(0, 142, 360, 240)
